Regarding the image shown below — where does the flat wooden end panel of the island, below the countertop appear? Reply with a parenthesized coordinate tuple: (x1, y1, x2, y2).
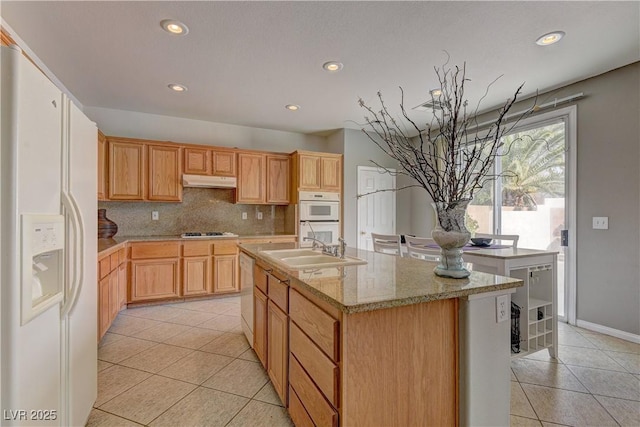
(342, 298, 458, 426)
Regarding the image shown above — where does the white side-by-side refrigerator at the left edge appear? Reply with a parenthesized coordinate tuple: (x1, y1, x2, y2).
(0, 47, 97, 426)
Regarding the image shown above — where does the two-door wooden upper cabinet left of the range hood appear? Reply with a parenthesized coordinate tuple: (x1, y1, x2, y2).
(104, 138, 182, 202)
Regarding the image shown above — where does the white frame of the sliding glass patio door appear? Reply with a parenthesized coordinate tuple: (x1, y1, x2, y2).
(493, 105, 578, 325)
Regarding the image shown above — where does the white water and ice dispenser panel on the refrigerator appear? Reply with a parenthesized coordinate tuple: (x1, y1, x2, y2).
(20, 214, 65, 325)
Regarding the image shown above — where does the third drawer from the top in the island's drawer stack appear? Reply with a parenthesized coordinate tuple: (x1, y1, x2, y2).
(289, 356, 338, 426)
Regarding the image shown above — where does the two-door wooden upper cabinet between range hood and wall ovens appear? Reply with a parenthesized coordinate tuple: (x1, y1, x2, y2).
(236, 152, 291, 205)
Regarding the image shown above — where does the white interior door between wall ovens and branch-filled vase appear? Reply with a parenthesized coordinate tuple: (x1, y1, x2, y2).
(358, 166, 396, 251)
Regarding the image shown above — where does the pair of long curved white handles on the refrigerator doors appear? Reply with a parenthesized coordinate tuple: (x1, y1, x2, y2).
(60, 191, 84, 317)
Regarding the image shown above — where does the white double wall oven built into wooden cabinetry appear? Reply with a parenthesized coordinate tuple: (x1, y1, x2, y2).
(298, 191, 340, 247)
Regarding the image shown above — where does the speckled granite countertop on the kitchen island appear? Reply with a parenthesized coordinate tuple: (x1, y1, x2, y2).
(240, 243, 523, 313)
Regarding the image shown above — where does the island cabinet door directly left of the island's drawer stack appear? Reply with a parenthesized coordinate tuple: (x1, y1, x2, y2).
(267, 300, 289, 405)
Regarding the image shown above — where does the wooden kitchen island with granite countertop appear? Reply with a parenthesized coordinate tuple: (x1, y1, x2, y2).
(240, 244, 523, 426)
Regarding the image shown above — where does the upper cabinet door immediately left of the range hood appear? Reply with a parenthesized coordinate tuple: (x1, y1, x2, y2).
(148, 145, 182, 202)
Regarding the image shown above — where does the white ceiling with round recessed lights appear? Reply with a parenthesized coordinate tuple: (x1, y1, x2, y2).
(0, 0, 640, 133)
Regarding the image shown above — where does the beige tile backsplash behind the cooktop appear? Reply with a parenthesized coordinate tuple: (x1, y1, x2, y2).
(96, 188, 296, 237)
